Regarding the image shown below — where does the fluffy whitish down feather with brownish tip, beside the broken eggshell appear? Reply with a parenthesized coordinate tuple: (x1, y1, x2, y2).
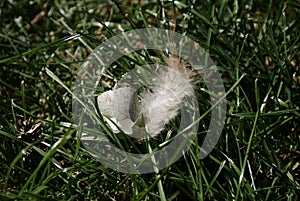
(141, 68, 194, 137)
